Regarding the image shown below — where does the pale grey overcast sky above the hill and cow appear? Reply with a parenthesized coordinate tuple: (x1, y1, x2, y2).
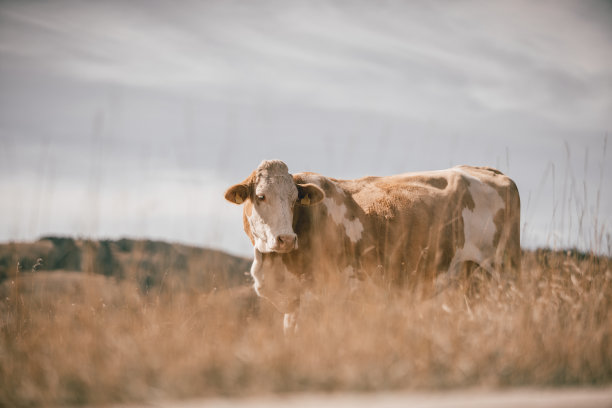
(0, 0, 612, 256)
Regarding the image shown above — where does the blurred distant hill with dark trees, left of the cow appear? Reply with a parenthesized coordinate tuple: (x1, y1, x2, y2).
(0, 236, 251, 292)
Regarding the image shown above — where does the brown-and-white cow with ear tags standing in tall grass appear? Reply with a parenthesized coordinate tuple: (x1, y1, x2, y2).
(225, 160, 521, 332)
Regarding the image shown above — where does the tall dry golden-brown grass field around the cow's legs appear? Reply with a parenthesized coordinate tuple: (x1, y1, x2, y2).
(0, 252, 612, 406)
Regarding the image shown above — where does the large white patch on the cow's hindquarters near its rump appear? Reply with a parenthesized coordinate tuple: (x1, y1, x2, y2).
(449, 169, 504, 273)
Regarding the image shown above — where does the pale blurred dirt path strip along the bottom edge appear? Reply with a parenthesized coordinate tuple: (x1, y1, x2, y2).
(117, 387, 612, 408)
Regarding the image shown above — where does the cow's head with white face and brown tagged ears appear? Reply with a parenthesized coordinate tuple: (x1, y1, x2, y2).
(225, 160, 325, 253)
